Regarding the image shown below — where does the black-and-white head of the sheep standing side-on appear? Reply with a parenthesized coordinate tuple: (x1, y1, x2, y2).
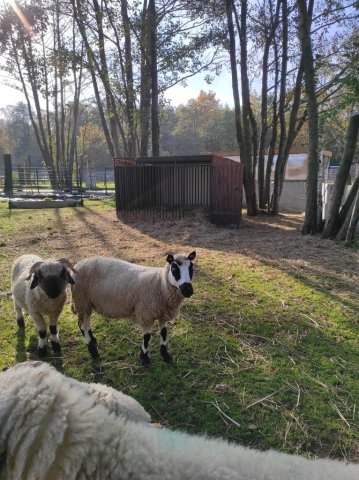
(167, 252, 196, 298)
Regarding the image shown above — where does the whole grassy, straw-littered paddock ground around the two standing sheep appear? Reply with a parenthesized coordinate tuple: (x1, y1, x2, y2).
(0, 200, 359, 461)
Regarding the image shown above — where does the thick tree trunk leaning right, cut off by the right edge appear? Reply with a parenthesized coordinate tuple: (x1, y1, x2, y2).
(323, 112, 359, 238)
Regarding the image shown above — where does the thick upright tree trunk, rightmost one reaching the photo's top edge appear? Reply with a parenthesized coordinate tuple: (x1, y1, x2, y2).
(297, 0, 319, 234)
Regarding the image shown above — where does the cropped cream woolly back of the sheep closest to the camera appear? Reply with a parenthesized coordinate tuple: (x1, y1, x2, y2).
(0, 362, 359, 480)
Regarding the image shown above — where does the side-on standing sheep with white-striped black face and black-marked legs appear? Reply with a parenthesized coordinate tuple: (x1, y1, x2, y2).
(71, 252, 196, 365)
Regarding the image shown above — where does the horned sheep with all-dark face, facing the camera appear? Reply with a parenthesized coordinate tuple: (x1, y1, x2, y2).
(11, 255, 74, 357)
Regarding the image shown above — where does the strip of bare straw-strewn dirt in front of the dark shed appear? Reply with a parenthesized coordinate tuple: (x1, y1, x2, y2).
(8, 204, 359, 302)
